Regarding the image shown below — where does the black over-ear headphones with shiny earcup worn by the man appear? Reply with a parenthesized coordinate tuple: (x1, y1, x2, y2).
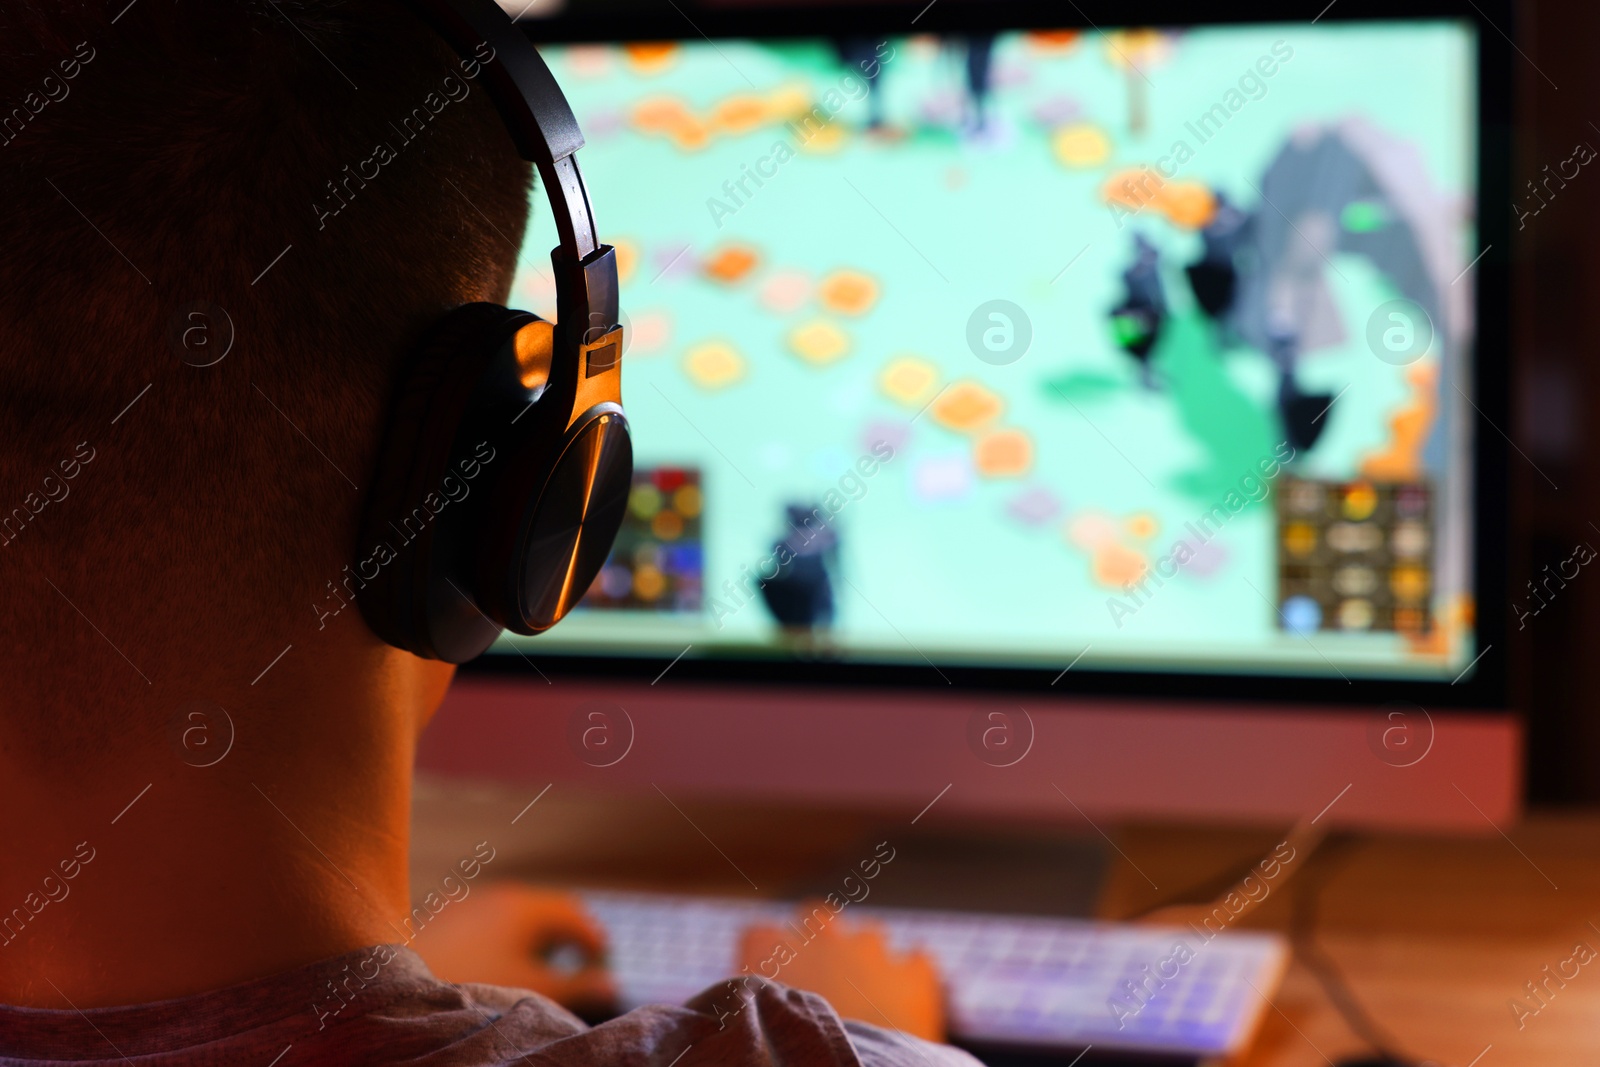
(347, 0, 634, 664)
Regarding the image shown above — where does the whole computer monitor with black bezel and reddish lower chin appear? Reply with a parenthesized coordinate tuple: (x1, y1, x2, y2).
(422, 0, 1520, 830)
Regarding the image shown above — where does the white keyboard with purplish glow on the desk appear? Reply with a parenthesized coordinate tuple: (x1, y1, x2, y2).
(581, 891, 1288, 1059)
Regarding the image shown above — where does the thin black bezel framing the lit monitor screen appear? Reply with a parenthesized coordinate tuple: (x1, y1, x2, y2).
(464, 0, 1514, 712)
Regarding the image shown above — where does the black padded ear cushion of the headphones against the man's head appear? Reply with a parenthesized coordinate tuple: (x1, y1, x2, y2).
(354, 304, 533, 662)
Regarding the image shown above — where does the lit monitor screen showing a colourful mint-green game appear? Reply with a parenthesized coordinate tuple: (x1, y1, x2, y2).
(498, 21, 1483, 681)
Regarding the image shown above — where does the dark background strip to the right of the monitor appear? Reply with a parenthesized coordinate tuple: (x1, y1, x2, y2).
(1504, 0, 1600, 803)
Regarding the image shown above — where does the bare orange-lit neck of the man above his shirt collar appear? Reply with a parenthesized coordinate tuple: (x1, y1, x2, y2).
(0, 640, 450, 1008)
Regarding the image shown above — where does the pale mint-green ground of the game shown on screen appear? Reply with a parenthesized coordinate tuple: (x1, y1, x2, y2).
(496, 22, 1477, 678)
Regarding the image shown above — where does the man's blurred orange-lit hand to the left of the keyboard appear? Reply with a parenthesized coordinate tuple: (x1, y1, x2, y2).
(411, 881, 616, 1014)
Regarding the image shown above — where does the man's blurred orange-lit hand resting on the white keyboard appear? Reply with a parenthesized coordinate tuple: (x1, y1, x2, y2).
(739, 904, 944, 1041)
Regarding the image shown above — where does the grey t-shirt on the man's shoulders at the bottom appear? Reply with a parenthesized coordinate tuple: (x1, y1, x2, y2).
(0, 945, 976, 1067)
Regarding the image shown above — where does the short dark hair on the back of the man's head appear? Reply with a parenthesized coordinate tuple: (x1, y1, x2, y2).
(0, 0, 531, 739)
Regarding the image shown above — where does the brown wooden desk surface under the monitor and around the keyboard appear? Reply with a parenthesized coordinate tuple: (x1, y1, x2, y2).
(411, 781, 1600, 1067)
